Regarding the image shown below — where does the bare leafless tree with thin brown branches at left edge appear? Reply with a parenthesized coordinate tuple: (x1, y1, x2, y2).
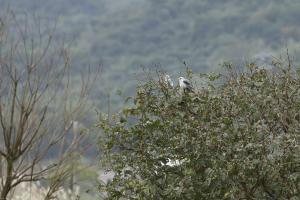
(0, 13, 99, 199)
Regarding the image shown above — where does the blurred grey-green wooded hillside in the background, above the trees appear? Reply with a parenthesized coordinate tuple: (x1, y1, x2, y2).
(0, 0, 300, 111)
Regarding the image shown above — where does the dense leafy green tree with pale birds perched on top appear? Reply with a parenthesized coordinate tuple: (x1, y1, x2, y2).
(100, 61, 300, 199)
